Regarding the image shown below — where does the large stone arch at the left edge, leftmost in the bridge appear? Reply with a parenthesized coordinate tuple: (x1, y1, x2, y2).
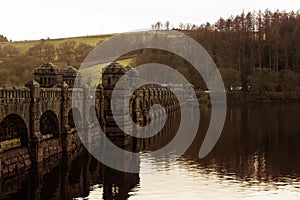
(0, 114, 28, 149)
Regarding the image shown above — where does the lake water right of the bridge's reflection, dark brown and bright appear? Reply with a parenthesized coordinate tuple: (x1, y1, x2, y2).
(137, 104, 300, 199)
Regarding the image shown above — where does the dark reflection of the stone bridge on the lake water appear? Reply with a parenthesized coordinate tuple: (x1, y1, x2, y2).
(0, 109, 180, 200)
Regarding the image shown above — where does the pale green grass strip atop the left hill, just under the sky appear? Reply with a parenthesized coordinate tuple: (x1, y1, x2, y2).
(0, 34, 114, 54)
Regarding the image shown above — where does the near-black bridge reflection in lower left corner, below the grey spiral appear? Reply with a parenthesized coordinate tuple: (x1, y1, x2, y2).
(1, 150, 139, 200)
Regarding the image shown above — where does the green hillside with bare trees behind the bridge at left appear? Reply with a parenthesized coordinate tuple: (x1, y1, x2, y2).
(0, 34, 134, 85)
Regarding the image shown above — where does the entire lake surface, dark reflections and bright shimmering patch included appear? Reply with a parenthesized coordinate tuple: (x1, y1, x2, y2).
(0, 103, 300, 200)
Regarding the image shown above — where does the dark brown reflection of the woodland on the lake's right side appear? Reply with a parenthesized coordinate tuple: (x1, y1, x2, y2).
(195, 104, 300, 181)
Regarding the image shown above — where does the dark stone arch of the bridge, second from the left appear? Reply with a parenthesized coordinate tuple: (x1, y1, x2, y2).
(40, 110, 60, 137)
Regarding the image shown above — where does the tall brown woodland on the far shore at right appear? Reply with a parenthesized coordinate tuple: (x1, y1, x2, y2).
(146, 10, 300, 99)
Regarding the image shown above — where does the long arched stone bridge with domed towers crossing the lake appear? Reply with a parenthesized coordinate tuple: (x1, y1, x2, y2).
(0, 63, 190, 175)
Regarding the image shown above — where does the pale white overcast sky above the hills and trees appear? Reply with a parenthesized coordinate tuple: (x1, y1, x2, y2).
(0, 0, 300, 40)
